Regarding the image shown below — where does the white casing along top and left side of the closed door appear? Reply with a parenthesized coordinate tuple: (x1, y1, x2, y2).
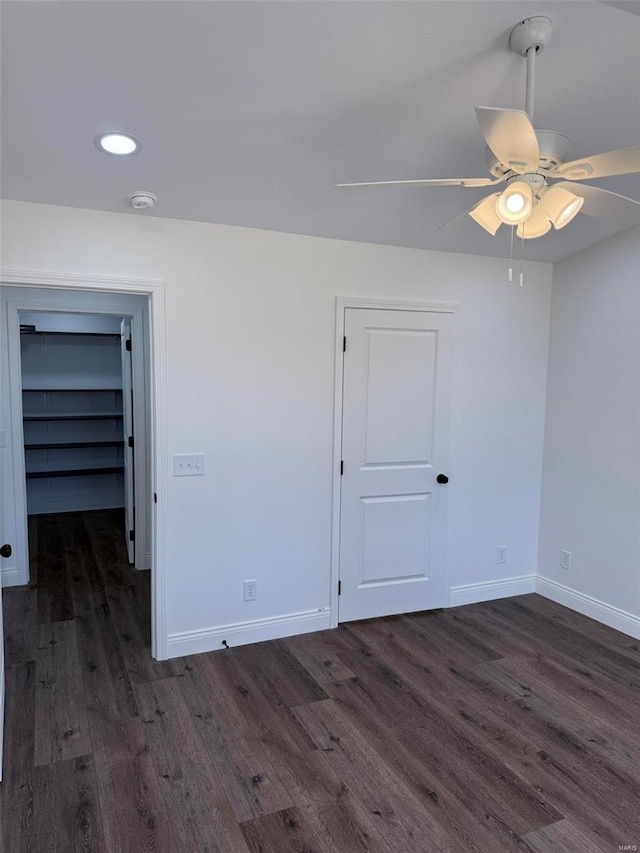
(329, 296, 460, 628)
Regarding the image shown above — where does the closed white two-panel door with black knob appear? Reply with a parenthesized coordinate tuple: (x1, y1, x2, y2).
(339, 308, 455, 622)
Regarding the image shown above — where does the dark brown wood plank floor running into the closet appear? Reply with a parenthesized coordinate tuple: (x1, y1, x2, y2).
(0, 511, 640, 853)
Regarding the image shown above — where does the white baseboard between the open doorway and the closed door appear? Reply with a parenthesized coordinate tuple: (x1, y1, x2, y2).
(167, 608, 331, 658)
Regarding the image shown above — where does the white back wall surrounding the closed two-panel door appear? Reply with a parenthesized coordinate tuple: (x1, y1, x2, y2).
(2, 202, 552, 653)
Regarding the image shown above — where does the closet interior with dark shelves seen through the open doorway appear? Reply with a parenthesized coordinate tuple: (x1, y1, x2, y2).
(20, 312, 130, 515)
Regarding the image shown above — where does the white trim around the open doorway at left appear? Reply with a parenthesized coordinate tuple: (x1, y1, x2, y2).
(0, 269, 169, 660)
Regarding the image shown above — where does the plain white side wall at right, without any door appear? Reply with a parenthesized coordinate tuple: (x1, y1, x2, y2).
(538, 228, 640, 637)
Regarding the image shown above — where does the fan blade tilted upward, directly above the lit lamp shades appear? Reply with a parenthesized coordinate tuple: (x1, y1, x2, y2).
(476, 107, 540, 175)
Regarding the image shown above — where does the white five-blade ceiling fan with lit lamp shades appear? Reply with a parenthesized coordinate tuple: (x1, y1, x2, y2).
(336, 16, 640, 239)
